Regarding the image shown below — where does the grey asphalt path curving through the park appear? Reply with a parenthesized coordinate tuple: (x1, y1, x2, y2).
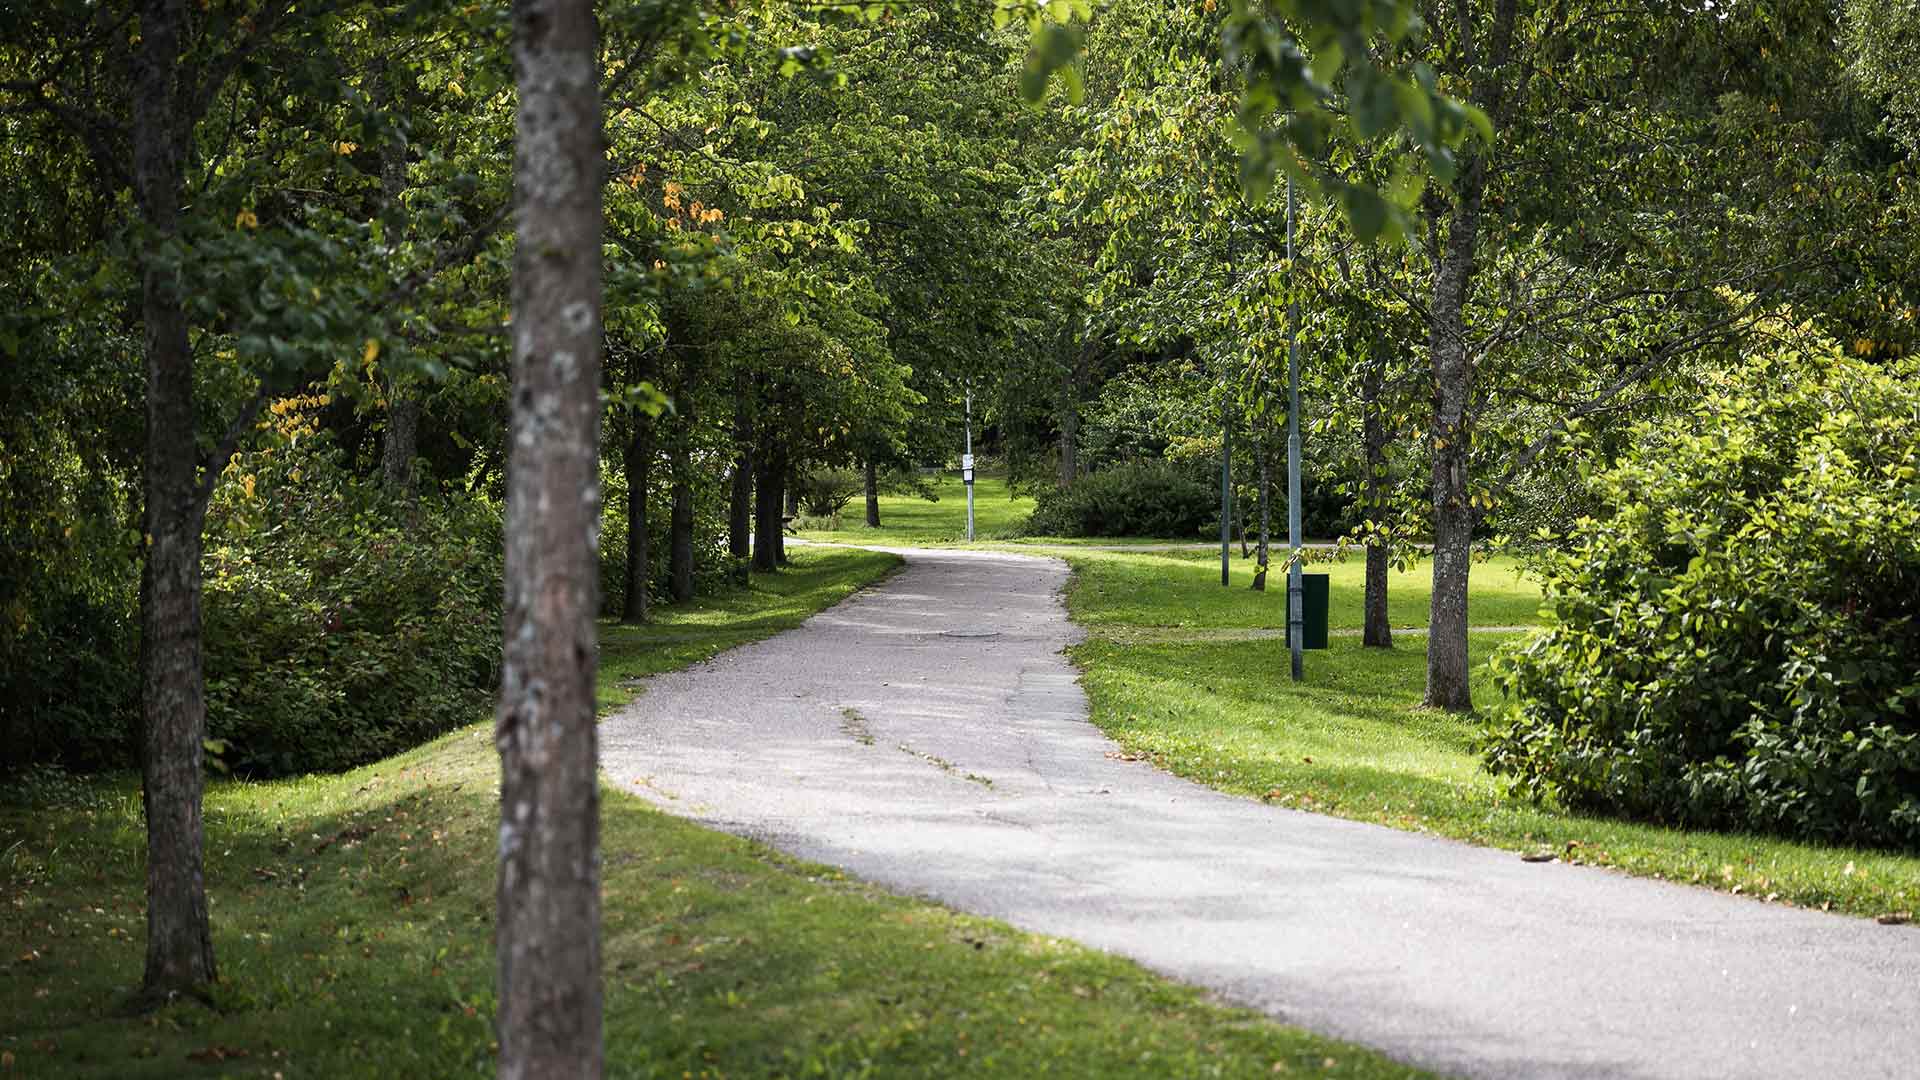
(601, 552, 1920, 1078)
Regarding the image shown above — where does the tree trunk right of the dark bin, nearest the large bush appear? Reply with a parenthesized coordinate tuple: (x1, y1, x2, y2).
(1425, 172, 1484, 713)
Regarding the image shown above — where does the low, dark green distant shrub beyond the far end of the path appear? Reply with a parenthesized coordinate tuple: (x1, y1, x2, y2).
(1025, 461, 1219, 536)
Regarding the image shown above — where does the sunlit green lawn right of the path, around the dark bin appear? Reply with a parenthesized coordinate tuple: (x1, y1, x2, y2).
(1068, 552, 1920, 915)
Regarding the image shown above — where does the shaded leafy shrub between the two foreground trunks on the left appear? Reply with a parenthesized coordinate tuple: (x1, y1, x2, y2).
(205, 417, 501, 776)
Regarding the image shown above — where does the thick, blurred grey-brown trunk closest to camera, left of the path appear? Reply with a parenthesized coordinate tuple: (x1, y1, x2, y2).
(493, 0, 605, 1080)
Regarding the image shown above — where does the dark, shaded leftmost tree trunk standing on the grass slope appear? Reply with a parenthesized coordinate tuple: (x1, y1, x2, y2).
(132, 0, 215, 1001)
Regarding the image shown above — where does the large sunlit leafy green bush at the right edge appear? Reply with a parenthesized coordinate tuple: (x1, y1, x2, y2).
(1486, 346, 1920, 847)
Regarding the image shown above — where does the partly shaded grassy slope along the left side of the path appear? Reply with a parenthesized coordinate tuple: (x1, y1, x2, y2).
(0, 552, 1409, 1078)
